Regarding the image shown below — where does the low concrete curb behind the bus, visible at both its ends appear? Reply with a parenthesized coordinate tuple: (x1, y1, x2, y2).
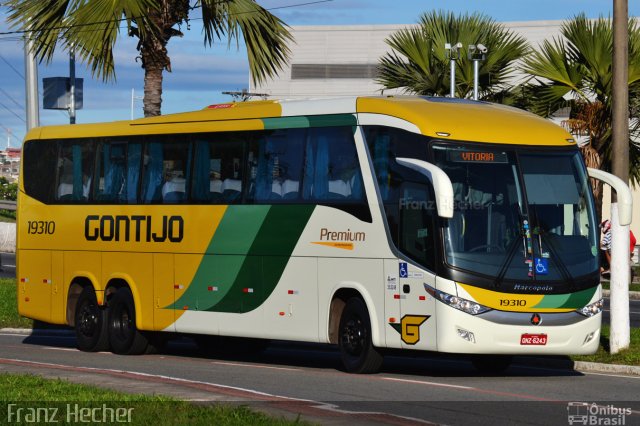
(5, 328, 640, 376)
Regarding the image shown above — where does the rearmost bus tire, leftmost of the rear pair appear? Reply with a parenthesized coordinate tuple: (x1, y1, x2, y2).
(74, 286, 109, 352)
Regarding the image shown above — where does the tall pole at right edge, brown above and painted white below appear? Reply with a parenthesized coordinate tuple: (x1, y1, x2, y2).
(609, 0, 630, 354)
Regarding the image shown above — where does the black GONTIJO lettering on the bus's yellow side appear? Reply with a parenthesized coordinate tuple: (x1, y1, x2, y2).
(84, 215, 184, 243)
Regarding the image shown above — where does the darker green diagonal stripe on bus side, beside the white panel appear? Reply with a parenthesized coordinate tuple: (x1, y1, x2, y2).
(206, 205, 315, 312)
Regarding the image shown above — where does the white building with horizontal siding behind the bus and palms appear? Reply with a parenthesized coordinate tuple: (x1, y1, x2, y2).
(249, 21, 640, 259)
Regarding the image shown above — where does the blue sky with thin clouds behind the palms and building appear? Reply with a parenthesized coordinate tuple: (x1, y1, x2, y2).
(0, 0, 640, 149)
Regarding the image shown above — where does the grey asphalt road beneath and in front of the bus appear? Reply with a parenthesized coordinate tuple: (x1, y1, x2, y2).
(0, 334, 640, 426)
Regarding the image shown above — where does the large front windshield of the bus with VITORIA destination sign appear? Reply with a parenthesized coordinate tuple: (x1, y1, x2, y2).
(433, 144, 598, 283)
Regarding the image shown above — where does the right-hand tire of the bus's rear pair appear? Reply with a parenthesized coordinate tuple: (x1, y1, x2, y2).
(109, 287, 149, 355)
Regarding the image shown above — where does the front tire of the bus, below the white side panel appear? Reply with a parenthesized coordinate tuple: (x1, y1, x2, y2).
(338, 297, 383, 374)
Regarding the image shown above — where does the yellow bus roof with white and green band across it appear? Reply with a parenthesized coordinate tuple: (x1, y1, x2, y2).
(26, 96, 575, 146)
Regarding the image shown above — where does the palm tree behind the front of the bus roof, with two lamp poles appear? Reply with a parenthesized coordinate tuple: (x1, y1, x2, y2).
(376, 11, 528, 99)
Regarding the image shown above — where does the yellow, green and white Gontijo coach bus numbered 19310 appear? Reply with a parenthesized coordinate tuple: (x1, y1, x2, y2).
(17, 97, 624, 373)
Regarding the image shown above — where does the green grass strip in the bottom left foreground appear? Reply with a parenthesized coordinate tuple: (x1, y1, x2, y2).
(0, 373, 309, 426)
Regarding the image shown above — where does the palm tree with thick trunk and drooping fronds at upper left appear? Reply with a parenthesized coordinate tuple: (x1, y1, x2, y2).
(5, 0, 292, 116)
